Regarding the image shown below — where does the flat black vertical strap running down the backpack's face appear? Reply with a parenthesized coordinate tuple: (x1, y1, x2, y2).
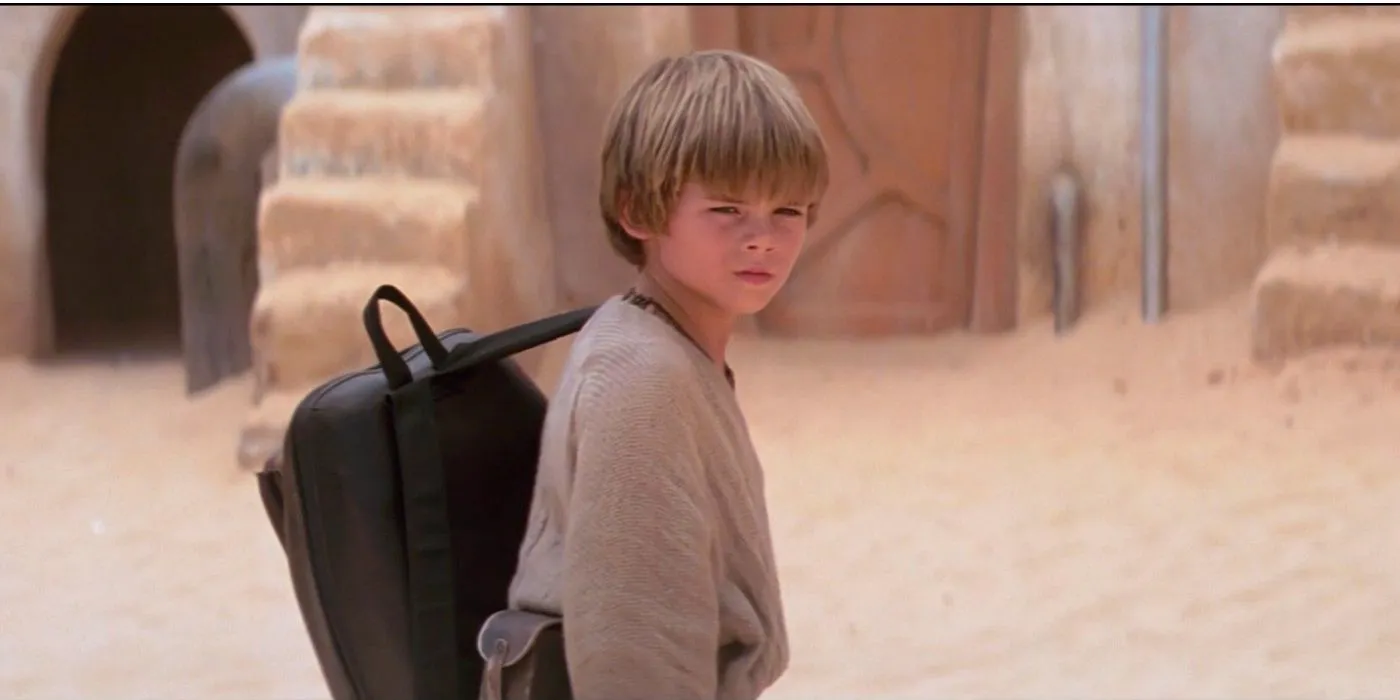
(391, 379, 462, 700)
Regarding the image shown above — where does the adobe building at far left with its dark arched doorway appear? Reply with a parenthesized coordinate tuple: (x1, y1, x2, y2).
(0, 6, 307, 357)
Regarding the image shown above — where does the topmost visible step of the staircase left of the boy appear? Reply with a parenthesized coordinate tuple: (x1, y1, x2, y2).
(297, 6, 505, 90)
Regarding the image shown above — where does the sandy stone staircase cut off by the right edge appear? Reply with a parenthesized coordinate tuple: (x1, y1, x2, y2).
(1253, 6, 1400, 361)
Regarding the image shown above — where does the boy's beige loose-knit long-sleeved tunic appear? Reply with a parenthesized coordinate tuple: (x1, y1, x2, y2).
(510, 297, 788, 700)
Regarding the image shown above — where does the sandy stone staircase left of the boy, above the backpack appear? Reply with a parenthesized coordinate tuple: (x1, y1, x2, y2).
(238, 6, 554, 468)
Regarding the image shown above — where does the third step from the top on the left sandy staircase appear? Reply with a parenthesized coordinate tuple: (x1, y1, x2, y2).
(258, 178, 479, 273)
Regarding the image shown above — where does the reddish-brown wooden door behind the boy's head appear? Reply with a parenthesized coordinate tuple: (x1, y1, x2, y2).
(716, 6, 988, 336)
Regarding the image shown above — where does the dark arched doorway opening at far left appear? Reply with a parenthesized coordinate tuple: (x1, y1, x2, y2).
(45, 6, 252, 356)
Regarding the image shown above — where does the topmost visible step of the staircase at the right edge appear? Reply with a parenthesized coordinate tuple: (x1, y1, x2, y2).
(1274, 14, 1400, 137)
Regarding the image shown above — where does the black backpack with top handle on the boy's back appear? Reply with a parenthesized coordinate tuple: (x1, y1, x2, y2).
(258, 286, 594, 700)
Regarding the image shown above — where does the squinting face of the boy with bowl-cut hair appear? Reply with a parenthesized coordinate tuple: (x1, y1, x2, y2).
(633, 183, 808, 315)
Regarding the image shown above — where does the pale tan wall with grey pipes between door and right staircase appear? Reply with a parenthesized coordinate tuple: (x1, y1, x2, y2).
(1018, 6, 1282, 321)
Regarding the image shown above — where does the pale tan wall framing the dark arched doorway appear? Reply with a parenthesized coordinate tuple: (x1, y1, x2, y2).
(0, 6, 307, 354)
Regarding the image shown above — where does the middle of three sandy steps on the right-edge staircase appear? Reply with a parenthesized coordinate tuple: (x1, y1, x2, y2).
(1266, 136, 1400, 248)
